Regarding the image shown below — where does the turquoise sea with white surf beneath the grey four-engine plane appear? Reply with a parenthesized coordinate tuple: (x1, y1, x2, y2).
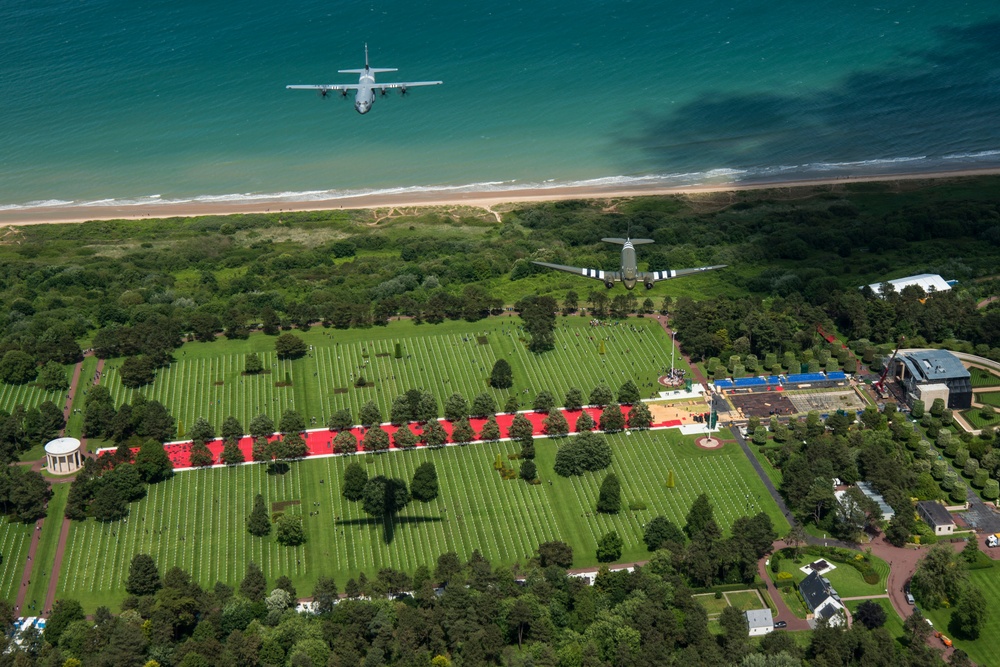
(0, 0, 1000, 208)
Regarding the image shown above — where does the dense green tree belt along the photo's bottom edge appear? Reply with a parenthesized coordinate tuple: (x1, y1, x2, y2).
(0, 506, 969, 667)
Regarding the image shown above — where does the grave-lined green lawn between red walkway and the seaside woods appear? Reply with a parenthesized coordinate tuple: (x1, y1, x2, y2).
(95, 317, 685, 428)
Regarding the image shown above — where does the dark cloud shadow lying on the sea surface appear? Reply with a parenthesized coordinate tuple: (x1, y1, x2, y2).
(618, 21, 1000, 173)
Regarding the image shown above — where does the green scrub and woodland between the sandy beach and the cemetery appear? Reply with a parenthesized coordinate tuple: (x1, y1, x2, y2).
(0, 177, 1000, 383)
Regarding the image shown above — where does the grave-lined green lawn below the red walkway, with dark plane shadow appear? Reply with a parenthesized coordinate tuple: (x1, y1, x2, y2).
(59, 430, 788, 610)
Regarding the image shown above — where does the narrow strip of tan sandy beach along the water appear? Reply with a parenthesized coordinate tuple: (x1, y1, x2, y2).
(0, 167, 1000, 226)
